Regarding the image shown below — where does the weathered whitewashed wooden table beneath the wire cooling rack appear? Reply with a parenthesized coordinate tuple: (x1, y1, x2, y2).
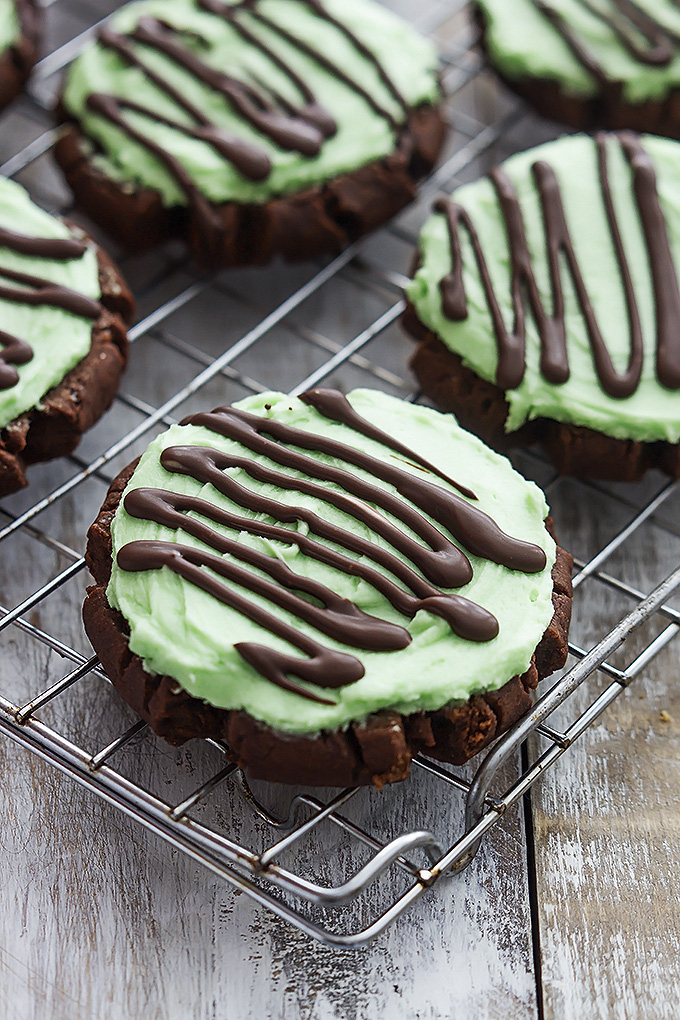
(0, 0, 680, 1020)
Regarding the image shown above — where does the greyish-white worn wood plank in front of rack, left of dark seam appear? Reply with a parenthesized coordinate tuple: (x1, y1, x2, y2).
(0, 743, 536, 1020)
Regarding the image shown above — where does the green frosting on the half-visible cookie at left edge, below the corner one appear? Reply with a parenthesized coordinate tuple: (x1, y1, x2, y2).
(0, 177, 101, 427)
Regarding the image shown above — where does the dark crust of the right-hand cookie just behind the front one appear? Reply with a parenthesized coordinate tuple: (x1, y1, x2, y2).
(402, 304, 680, 481)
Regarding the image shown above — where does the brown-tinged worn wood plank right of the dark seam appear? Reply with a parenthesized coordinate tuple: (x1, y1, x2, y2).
(532, 479, 680, 1020)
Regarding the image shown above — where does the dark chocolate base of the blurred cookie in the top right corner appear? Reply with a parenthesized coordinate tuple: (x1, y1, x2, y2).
(473, 5, 680, 140)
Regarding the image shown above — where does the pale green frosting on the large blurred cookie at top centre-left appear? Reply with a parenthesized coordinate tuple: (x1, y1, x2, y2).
(63, 0, 439, 206)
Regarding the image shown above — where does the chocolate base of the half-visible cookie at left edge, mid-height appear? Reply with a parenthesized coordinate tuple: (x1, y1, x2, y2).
(0, 228, 135, 496)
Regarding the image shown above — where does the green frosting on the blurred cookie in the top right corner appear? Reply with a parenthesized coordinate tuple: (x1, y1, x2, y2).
(476, 0, 680, 103)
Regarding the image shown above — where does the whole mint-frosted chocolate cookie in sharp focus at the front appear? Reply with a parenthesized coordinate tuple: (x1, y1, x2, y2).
(84, 390, 572, 786)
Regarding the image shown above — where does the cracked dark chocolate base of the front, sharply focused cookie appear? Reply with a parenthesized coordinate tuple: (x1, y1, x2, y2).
(83, 463, 572, 787)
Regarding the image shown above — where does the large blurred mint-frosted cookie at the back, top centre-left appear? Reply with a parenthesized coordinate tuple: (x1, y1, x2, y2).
(55, 0, 444, 266)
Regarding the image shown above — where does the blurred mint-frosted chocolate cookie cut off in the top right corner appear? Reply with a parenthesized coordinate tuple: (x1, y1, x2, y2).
(474, 0, 680, 138)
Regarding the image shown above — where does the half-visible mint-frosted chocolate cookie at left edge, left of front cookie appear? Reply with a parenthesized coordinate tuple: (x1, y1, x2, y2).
(0, 177, 135, 496)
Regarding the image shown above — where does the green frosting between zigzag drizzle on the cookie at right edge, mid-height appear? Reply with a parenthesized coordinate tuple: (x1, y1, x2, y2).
(408, 136, 680, 443)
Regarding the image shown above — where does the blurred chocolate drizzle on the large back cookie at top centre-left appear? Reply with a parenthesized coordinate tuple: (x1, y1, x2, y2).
(87, 0, 408, 238)
